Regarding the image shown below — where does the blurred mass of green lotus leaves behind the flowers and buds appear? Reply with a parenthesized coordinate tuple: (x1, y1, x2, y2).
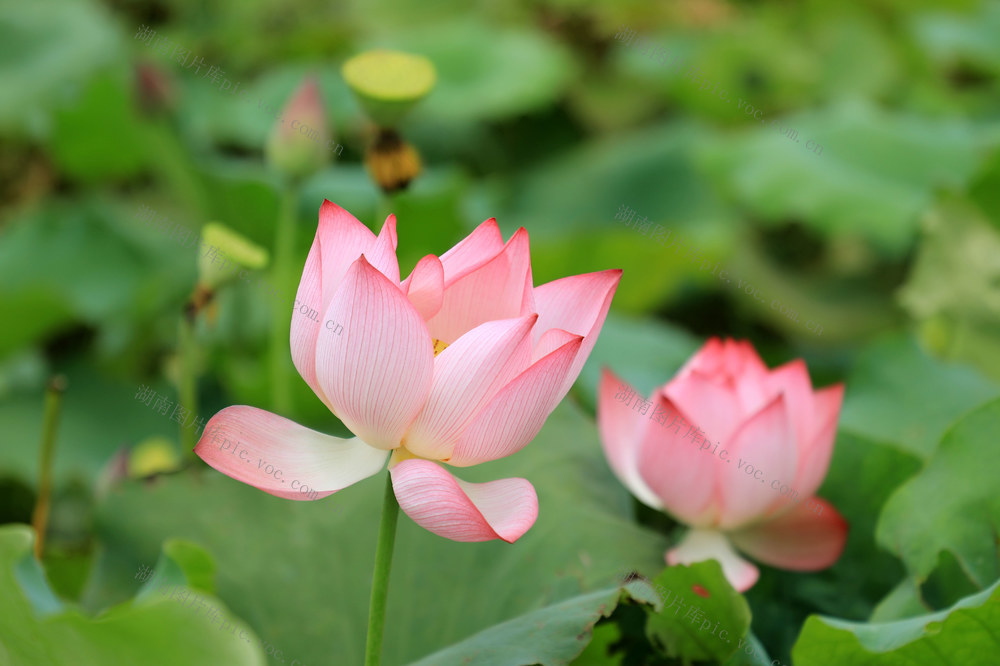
(0, 0, 1000, 664)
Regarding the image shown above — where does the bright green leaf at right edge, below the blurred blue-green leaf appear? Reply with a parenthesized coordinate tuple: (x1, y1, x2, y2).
(878, 400, 1000, 588)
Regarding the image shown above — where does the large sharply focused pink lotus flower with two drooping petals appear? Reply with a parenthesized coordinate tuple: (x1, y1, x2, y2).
(195, 201, 621, 542)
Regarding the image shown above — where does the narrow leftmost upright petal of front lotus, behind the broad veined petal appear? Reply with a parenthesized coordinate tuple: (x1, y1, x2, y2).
(289, 238, 333, 411)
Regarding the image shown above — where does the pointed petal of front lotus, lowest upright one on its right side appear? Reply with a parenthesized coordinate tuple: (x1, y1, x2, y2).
(447, 335, 583, 467)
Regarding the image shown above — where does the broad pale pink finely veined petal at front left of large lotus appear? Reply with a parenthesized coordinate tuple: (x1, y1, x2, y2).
(316, 257, 434, 449)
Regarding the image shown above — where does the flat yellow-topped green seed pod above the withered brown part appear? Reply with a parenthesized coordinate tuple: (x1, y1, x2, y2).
(341, 50, 437, 128)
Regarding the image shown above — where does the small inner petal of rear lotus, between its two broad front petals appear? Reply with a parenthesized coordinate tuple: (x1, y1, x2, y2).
(660, 368, 745, 447)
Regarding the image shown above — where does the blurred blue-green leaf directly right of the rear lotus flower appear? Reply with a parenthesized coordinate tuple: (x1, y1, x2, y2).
(840, 336, 1000, 459)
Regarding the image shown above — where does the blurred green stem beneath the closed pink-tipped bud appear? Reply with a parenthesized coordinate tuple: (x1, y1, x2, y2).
(271, 184, 298, 414)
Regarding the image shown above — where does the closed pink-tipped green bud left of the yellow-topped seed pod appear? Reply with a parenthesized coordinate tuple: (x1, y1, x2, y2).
(265, 78, 330, 179)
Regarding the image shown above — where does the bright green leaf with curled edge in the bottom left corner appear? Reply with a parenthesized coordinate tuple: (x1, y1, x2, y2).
(0, 525, 264, 666)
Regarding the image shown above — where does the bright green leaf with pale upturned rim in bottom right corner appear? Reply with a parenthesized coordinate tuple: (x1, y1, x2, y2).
(792, 583, 1000, 666)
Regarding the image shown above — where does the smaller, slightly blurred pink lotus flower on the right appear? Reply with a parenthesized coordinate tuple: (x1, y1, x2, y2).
(598, 338, 847, 592)
